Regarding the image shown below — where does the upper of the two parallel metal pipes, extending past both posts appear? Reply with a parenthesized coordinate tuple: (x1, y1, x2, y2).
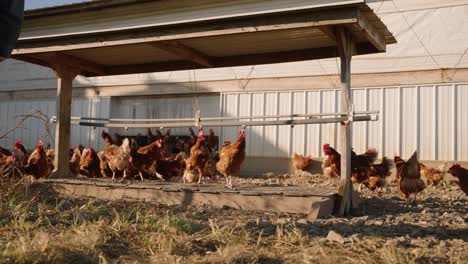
(66, 111, 379, 122)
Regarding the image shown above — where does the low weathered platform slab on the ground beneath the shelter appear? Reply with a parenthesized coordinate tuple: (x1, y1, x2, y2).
(36, 178, 336, 219)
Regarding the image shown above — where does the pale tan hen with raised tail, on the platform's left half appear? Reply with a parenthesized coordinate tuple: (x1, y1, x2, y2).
(104, 138, 130, 181)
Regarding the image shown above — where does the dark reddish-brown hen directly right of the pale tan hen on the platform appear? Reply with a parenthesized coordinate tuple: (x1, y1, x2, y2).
(130, 139, 163, 181)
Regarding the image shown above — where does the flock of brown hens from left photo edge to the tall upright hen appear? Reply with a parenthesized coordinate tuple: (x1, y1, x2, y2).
(0, 128, 245, 188)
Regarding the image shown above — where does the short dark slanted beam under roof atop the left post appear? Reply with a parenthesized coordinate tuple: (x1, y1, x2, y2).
(28, 52, 106, 76)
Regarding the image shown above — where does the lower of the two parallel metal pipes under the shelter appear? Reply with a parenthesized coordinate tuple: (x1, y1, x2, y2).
(78, 115, 375, 128)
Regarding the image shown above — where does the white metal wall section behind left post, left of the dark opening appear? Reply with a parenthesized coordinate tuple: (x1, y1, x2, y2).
(0, 98, 110, 149)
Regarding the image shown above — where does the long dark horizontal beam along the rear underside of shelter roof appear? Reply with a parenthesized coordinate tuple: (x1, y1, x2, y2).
(107, 47, 337, 75)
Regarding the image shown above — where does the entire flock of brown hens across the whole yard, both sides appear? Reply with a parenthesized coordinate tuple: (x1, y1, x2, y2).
(0, 128, 468, 200)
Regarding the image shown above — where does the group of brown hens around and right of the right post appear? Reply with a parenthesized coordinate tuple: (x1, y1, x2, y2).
(293, 144, 468, 203)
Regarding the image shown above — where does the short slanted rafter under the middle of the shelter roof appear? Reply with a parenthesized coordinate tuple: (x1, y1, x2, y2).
(151, 41, 215, 68)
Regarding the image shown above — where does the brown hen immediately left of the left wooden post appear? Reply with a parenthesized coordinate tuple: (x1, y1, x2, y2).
(24, 141, 52, 179)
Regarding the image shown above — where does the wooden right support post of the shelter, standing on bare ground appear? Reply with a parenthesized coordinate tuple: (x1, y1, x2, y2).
(336, 27, 354, 216)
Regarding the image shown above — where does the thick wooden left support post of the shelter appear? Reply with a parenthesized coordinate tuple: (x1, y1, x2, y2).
(50, 65, 78, 178)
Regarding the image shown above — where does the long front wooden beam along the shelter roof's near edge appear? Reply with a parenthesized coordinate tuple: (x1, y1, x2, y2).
(13, 7, 358, 54)
